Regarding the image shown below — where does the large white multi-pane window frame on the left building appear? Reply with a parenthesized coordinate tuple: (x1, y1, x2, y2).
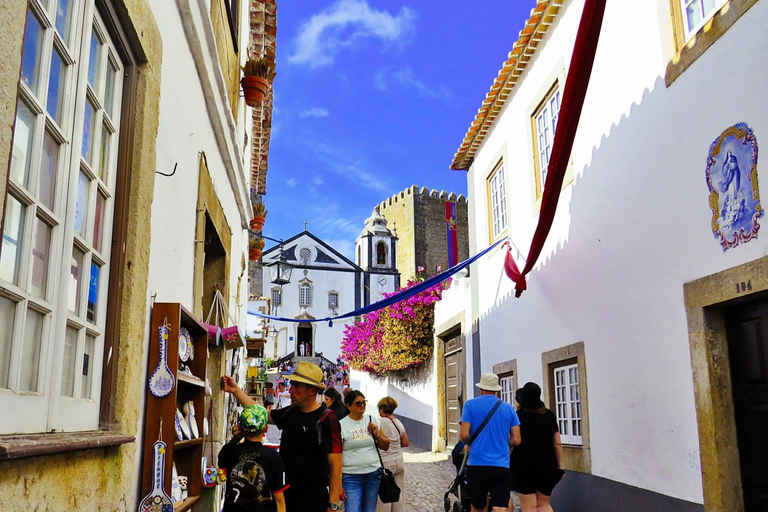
(0, 0, 124, 434)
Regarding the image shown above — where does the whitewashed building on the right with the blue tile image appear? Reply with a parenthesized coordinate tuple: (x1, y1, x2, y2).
(433, 0, 768, 512)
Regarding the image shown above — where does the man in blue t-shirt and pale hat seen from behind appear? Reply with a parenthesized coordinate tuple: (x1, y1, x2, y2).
(459, 373, 520, 512)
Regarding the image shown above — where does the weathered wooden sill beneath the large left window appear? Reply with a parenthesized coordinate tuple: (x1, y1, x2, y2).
(0, 430, 136, 461)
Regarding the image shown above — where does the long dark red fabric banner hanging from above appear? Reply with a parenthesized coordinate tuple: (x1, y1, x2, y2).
(504, 0, 606, 297)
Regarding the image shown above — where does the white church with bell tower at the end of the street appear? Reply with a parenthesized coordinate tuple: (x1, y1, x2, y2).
(260, 228, 400, 361)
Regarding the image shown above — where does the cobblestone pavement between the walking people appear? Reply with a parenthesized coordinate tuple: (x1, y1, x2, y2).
(403, 445, 520, 512)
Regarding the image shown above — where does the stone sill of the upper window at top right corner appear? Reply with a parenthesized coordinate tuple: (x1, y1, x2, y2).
(664, 0, 757, 87)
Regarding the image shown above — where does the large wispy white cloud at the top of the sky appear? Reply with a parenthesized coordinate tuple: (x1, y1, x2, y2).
(288, 0, 416, 68)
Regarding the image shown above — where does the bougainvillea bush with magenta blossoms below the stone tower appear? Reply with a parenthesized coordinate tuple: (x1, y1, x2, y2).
(341, 281, 443, 376)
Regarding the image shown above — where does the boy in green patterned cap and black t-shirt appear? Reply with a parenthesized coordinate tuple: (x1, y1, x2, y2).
(219, 404, 288, 512)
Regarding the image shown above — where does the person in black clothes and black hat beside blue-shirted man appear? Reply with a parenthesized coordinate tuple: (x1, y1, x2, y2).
(510, 382, 565, 512)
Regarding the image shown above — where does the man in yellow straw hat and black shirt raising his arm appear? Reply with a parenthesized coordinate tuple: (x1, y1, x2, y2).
(221, 362, 341, 512)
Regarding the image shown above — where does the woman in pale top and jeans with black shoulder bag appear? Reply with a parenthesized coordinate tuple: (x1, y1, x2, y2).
(340, 390, 389, 512)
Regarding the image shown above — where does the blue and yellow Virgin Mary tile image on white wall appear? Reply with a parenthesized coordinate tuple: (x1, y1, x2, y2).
(707, 123, 765, 251)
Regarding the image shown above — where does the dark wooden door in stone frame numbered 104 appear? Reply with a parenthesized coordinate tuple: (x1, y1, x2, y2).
(726, 299, 768, 512)
